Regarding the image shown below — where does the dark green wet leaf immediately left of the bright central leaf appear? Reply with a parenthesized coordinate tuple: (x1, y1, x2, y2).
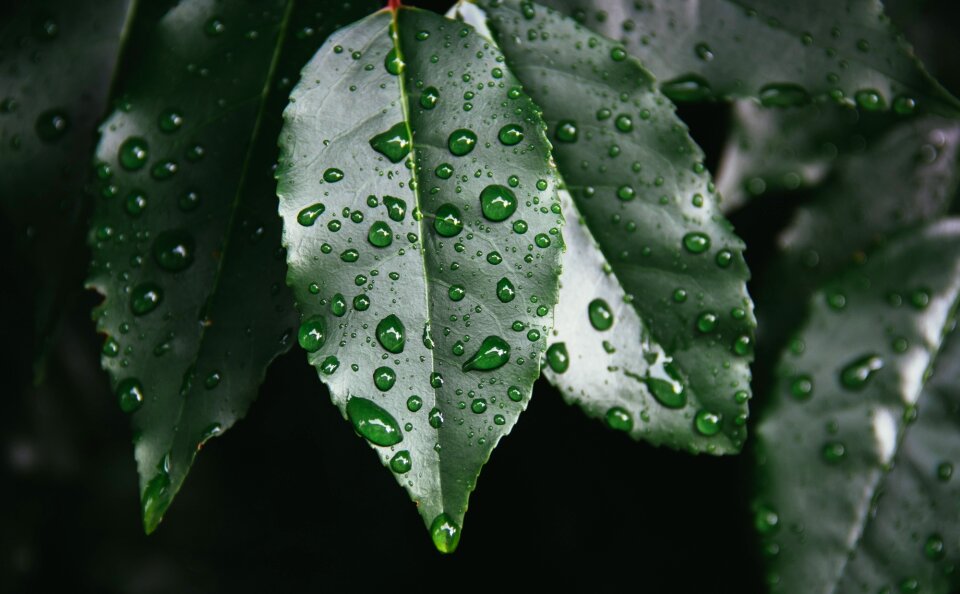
(88, 0, 372, 533)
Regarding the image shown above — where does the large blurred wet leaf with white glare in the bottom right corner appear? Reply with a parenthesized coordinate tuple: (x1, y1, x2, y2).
(755, 219, 960, 592)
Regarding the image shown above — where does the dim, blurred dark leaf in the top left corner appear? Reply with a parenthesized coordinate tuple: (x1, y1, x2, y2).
(0, 0, 128, 376)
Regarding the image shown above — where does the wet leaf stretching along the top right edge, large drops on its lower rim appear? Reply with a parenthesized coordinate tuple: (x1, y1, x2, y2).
(545, 0, 960, 115)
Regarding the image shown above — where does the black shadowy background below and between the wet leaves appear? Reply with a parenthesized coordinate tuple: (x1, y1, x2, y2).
(0, 0, 960, 594)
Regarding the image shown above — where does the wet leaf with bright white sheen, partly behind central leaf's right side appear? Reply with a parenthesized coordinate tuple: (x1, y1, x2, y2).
(458, 0, 754, 454)
